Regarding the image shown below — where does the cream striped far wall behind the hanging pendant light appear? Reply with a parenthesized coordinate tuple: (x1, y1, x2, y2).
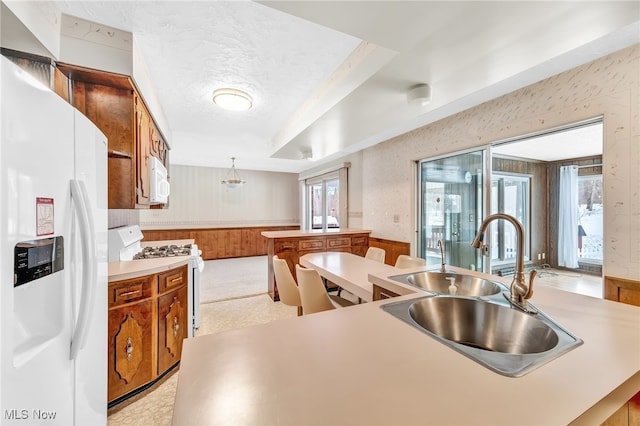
(140, 165, 300, 229)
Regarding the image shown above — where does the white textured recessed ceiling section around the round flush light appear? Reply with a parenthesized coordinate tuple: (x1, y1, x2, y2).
(53, 1, 360, 170)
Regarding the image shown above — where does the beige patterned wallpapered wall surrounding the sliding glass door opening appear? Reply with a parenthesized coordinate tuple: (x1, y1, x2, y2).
(362, 45, 640, 280)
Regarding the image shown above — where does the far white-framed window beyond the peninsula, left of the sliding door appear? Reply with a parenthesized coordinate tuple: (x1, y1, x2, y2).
(305, 168, 347, 230)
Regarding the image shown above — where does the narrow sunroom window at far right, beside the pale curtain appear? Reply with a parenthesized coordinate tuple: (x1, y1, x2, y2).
(578, 175, 603, 264)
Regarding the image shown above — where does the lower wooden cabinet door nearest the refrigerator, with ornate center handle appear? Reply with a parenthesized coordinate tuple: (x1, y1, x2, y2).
(107, 299, 155, 401)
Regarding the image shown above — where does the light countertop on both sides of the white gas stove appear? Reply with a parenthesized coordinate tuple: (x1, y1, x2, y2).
(108, 239, 194, 282)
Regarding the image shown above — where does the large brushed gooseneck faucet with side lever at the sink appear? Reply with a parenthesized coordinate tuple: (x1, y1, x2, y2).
(471, 213, 536, 312)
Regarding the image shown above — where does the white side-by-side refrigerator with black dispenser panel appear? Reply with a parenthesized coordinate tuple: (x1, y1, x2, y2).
(0, 57, 108, 425)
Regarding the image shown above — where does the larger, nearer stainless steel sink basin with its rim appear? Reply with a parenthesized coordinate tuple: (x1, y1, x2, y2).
(382, 294, 582, 377)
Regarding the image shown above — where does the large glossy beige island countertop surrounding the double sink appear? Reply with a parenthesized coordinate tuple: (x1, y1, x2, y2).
(173, 268, 640, 425)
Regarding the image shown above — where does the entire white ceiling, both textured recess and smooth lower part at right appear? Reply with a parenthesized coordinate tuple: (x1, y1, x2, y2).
(57, 1, 640, 172)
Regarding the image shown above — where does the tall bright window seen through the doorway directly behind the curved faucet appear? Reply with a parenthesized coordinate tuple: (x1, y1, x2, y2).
(489, 172, 531, 264)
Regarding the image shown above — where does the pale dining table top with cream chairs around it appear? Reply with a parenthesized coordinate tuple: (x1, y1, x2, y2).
(300, 251, 403, 302)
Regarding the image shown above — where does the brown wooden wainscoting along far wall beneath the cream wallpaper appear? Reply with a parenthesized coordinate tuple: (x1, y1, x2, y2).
(142, 226, 300, 260)
